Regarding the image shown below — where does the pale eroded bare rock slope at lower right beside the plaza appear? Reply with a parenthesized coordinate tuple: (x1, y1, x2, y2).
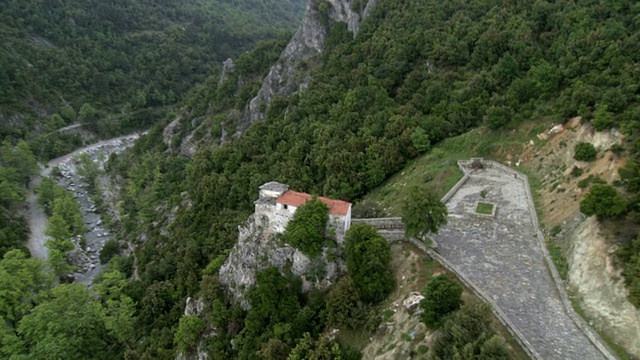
(567, 215, 640, 357)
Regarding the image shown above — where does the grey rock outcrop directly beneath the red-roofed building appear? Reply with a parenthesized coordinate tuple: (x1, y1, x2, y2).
(219, 215, 345, 309)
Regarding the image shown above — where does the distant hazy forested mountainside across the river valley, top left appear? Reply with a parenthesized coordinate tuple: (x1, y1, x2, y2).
(0, 0, 304, 148)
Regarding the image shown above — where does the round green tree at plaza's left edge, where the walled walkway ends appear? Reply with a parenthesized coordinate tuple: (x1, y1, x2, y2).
(402, 188, 448, 239)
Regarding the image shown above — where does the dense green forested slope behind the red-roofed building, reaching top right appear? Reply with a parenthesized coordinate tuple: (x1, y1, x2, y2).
(99, 0, 640, 356)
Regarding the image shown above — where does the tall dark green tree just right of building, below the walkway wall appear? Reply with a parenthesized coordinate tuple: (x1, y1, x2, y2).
(344, 223, 395, 303)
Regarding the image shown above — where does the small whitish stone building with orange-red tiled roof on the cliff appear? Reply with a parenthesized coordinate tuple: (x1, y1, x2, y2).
(255, 181, 351, 239)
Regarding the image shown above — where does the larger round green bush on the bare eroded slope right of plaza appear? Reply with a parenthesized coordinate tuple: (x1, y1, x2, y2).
(580, 184, 627, 219)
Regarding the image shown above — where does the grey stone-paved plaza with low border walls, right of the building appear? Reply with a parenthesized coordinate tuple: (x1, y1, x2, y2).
(433, 167, 605, 360)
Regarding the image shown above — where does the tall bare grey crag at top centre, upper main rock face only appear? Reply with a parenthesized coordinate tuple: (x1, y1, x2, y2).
(244, 0, 377, 132)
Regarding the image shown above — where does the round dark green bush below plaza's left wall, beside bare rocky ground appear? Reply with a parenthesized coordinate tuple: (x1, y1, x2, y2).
(420, 275, 462, 329)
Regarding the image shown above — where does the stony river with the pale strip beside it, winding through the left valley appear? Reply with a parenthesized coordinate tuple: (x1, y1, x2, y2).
(27, 133, 140, 285)
